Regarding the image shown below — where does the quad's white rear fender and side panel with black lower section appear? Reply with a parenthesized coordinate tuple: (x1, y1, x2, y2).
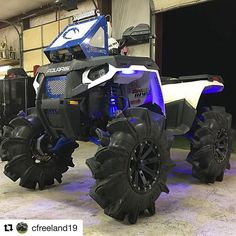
(162, 80, 224, 135)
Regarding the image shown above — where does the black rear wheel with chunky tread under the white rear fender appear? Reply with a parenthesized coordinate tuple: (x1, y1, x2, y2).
(187, 107, 234, 183)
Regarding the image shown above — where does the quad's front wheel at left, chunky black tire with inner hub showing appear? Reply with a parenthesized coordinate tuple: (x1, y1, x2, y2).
(1, 110, 78, 190)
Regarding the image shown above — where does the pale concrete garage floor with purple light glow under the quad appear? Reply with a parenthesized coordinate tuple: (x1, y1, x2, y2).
(0, 143, 236, 236)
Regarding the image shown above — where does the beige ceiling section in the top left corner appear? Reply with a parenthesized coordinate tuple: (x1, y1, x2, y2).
(0, 0, 55, 20)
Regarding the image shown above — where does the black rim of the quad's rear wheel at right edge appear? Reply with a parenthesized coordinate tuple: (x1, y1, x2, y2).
(214, 129, 228, 163)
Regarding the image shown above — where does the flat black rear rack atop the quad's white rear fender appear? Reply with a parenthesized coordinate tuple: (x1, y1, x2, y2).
(161, 74, 223, 84)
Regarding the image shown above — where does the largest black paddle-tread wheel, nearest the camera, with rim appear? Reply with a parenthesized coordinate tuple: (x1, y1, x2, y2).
(86, 108, 173, 224)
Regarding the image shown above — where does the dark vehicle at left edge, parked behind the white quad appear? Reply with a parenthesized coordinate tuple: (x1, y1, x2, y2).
(0, 68, 35, 161)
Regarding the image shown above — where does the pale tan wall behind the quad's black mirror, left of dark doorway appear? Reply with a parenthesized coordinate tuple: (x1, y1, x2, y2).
(112, 0, 150, 57)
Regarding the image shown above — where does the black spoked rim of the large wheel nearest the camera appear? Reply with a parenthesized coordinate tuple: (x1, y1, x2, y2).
(128, 140, 161, 193)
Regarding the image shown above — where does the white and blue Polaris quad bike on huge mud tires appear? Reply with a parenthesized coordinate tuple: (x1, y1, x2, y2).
(1, 10, 233, 223)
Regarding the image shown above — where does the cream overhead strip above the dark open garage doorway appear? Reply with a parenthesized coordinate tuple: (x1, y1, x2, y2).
(151, 0, 209, 12)
